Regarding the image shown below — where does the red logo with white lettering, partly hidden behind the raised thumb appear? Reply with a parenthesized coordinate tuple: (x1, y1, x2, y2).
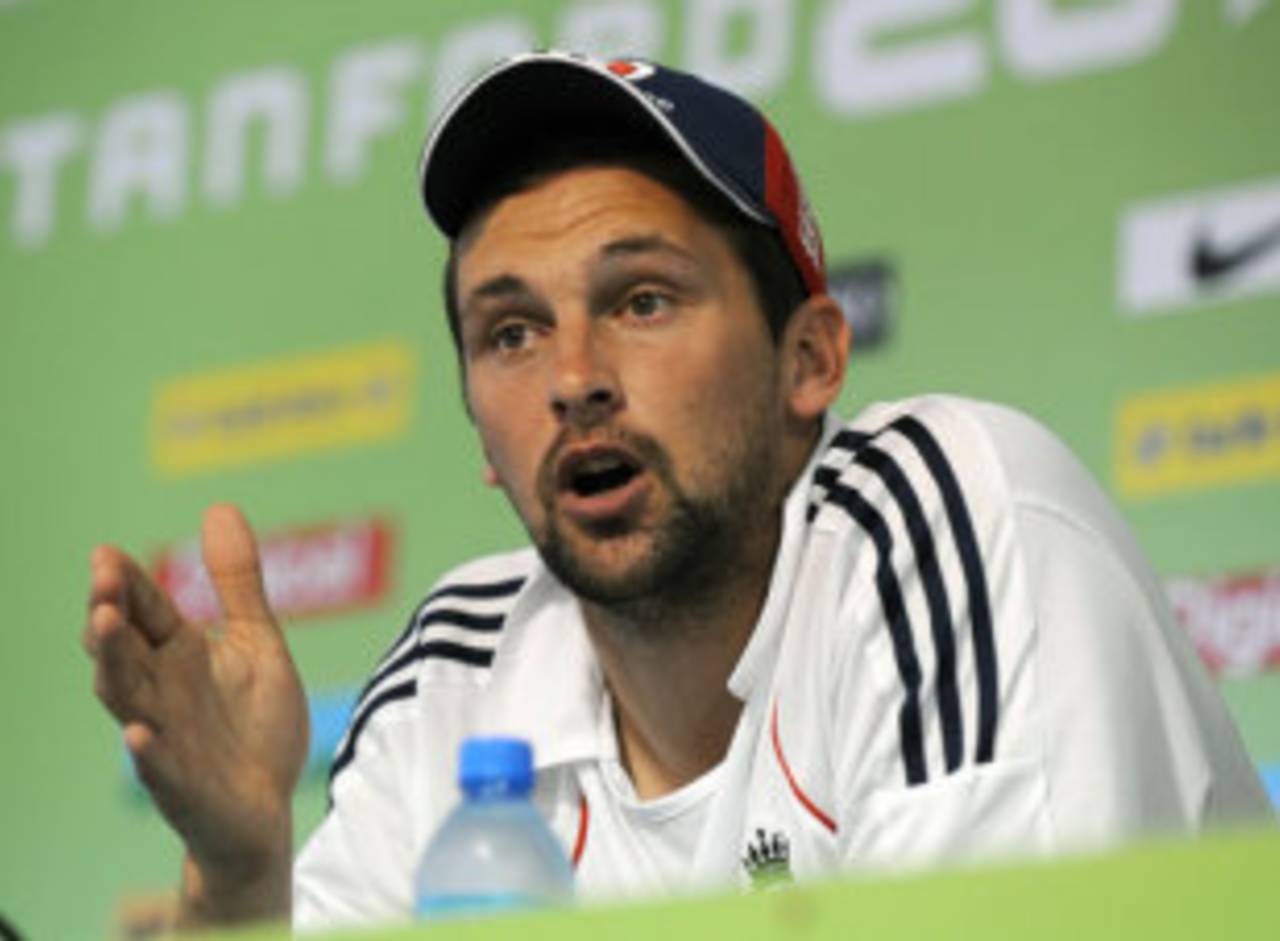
(152, 519, 392, 623)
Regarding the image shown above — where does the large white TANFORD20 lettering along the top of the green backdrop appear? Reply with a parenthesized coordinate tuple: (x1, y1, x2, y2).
(0, 0, 1258, 248)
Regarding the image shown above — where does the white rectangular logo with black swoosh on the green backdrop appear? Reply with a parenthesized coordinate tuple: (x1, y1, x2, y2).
(1117, 177, 1280, 316)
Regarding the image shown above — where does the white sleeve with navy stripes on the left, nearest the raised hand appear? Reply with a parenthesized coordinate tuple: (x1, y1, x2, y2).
(293, 552, 532, 931)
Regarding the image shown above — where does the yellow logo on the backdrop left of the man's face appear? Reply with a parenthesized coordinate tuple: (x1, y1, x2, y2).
(150, 341, 415, 476)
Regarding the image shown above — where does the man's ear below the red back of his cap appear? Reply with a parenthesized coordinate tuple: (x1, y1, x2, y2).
(782, 294, 852, 420)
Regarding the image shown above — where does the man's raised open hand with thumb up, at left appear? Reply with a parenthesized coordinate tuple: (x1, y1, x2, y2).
(84, 504, 307, 924)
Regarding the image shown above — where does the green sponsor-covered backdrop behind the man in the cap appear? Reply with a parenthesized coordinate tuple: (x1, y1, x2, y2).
(0, 0, 1280, 938)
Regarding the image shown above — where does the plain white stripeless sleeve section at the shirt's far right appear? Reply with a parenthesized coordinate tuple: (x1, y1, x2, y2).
(1019, 494, 1270, 848)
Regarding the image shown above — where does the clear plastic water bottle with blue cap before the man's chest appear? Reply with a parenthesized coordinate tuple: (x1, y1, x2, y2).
(415, 739, 573, 919)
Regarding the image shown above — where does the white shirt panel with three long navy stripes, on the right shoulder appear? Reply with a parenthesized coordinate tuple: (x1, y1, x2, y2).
(815, 399, 1055, 869)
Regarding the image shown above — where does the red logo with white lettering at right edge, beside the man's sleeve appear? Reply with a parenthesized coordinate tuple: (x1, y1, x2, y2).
(1167, 568, 1280, 676)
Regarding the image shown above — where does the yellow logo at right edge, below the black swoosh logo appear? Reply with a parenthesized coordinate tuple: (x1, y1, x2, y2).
(1115, 374, 1280, 497)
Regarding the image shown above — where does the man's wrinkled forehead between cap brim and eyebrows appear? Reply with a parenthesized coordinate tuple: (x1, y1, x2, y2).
(457, 166, 728, 281)
